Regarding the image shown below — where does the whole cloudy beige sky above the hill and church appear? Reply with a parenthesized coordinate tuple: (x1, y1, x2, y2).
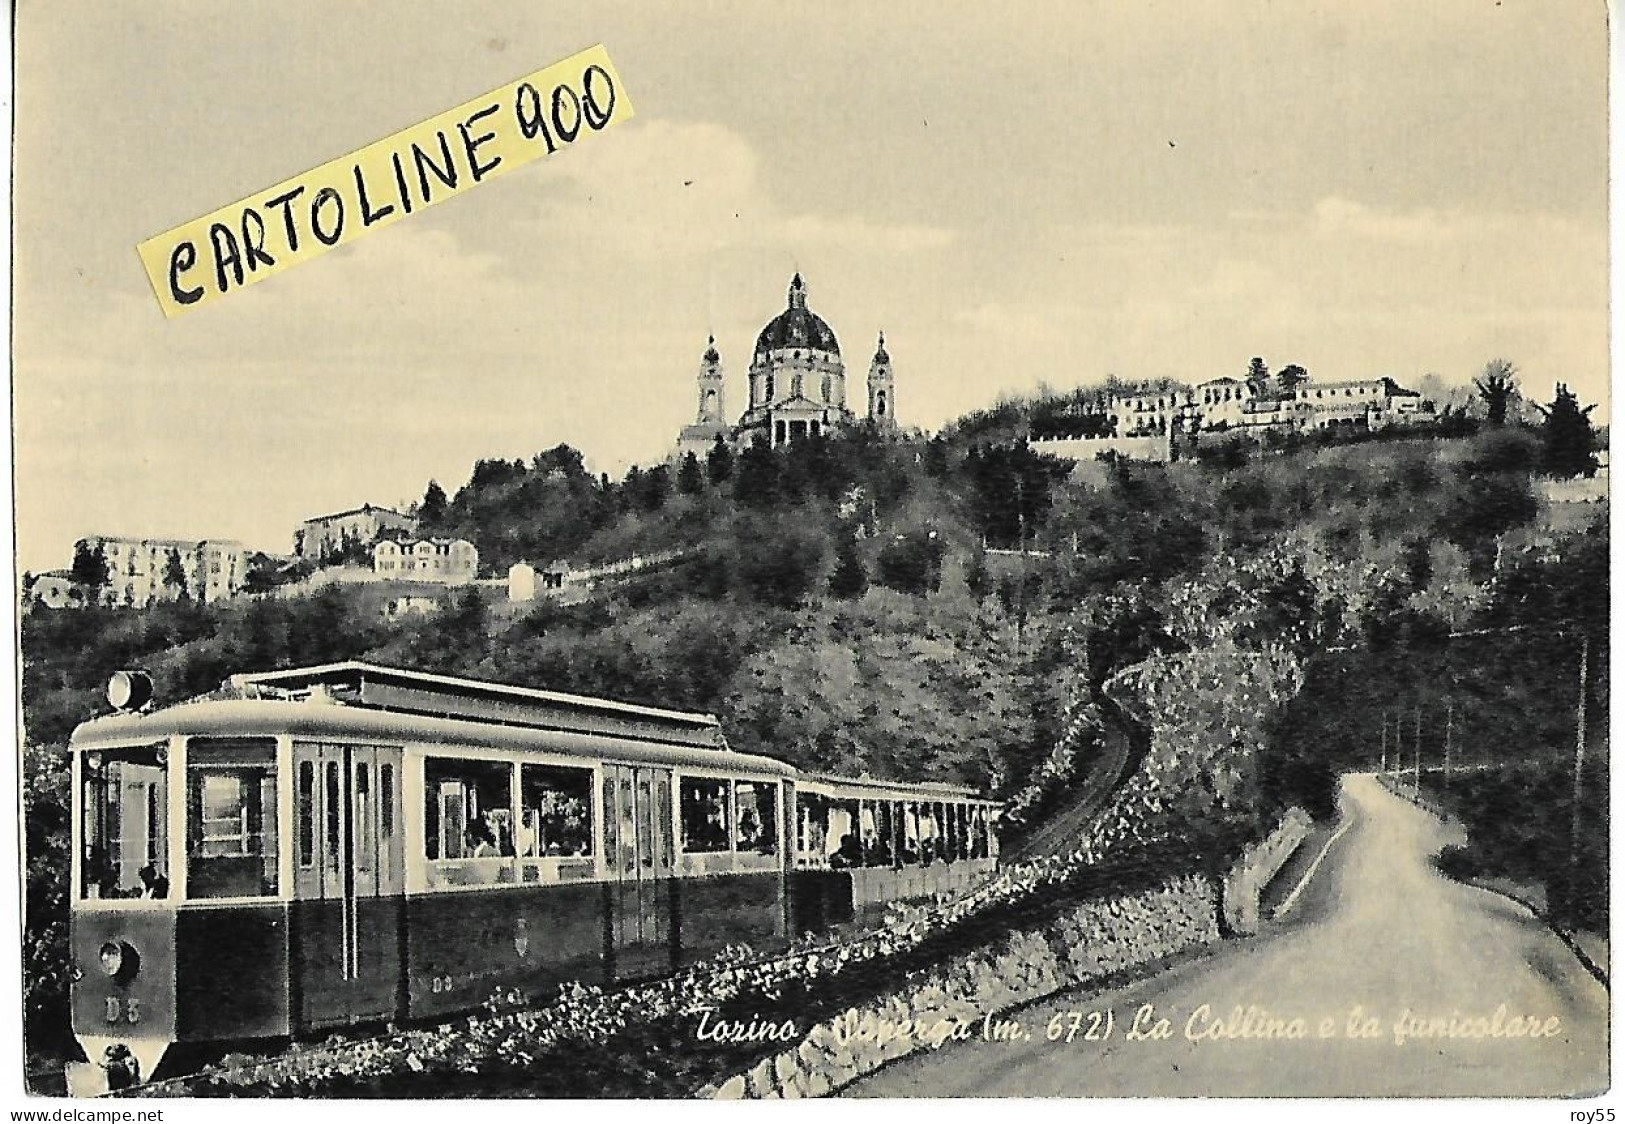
(13, 0, 1609, 570)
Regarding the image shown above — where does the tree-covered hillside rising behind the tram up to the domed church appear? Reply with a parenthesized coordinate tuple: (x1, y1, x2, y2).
(23, 375, 1607, 1065)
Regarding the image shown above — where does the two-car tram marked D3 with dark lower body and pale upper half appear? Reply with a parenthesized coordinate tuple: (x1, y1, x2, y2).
(70, 663, 998, 1088)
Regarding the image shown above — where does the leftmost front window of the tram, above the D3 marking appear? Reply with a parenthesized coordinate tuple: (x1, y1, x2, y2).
(80, 746, 169, 900)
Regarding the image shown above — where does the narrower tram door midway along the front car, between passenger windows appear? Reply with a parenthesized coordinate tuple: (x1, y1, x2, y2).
(603, 765, 676, 979)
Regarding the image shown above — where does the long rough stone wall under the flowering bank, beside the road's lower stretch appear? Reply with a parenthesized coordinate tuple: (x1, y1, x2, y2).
(699, 875, 1219, 1100)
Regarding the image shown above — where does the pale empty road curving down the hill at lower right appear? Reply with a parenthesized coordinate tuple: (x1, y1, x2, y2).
(847, 775, 1609, 1096)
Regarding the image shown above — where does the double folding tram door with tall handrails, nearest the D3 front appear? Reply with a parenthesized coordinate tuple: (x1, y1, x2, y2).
(294, 744, 403, 1027)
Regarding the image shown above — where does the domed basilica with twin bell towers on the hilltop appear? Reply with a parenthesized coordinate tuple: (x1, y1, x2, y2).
(676, 273, 897, 460)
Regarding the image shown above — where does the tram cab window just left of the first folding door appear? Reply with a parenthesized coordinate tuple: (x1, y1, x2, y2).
(187, 737, 278, 898)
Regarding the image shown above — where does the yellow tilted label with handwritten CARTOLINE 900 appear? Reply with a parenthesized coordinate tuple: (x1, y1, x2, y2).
(137, 44, 632, 317)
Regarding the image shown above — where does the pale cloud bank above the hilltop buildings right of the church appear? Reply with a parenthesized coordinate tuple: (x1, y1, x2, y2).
(923, 198, 1609, 415)
